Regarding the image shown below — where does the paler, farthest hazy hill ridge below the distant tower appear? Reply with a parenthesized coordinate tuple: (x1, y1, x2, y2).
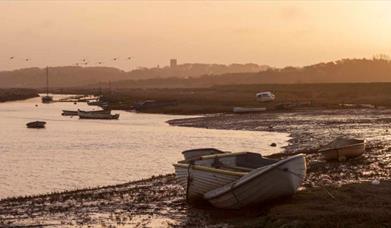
(0, 63, 268, 88)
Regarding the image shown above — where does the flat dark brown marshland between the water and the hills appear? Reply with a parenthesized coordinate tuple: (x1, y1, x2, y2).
(89, 83, 391, 114)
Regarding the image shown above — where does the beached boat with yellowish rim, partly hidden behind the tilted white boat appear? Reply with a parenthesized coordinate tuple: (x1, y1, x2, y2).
(174, 152, 277, 201)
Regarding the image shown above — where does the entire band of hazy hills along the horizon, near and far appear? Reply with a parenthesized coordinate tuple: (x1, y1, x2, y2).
(0, 58, 391, 88)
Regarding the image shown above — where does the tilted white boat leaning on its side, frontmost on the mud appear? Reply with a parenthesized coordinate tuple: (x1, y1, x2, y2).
(204, 154, 306, 209)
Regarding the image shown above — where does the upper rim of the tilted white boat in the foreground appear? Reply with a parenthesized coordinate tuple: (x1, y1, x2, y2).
(204, 154, 306, 200)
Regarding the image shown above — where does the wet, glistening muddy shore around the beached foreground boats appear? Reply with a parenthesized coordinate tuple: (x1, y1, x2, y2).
(0, 109, 391, 227)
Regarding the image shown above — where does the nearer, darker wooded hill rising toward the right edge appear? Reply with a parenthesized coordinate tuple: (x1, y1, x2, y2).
(102, 59, 391, 88)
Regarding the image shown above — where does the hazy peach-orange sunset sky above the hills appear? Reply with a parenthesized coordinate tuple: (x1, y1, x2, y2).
(0, 1, 391, 70)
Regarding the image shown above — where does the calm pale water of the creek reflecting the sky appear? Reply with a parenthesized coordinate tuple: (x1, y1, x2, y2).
(0, 95, 289, 198)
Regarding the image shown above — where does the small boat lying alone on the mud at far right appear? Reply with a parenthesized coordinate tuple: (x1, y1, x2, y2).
(319, 137, 365, 161)
